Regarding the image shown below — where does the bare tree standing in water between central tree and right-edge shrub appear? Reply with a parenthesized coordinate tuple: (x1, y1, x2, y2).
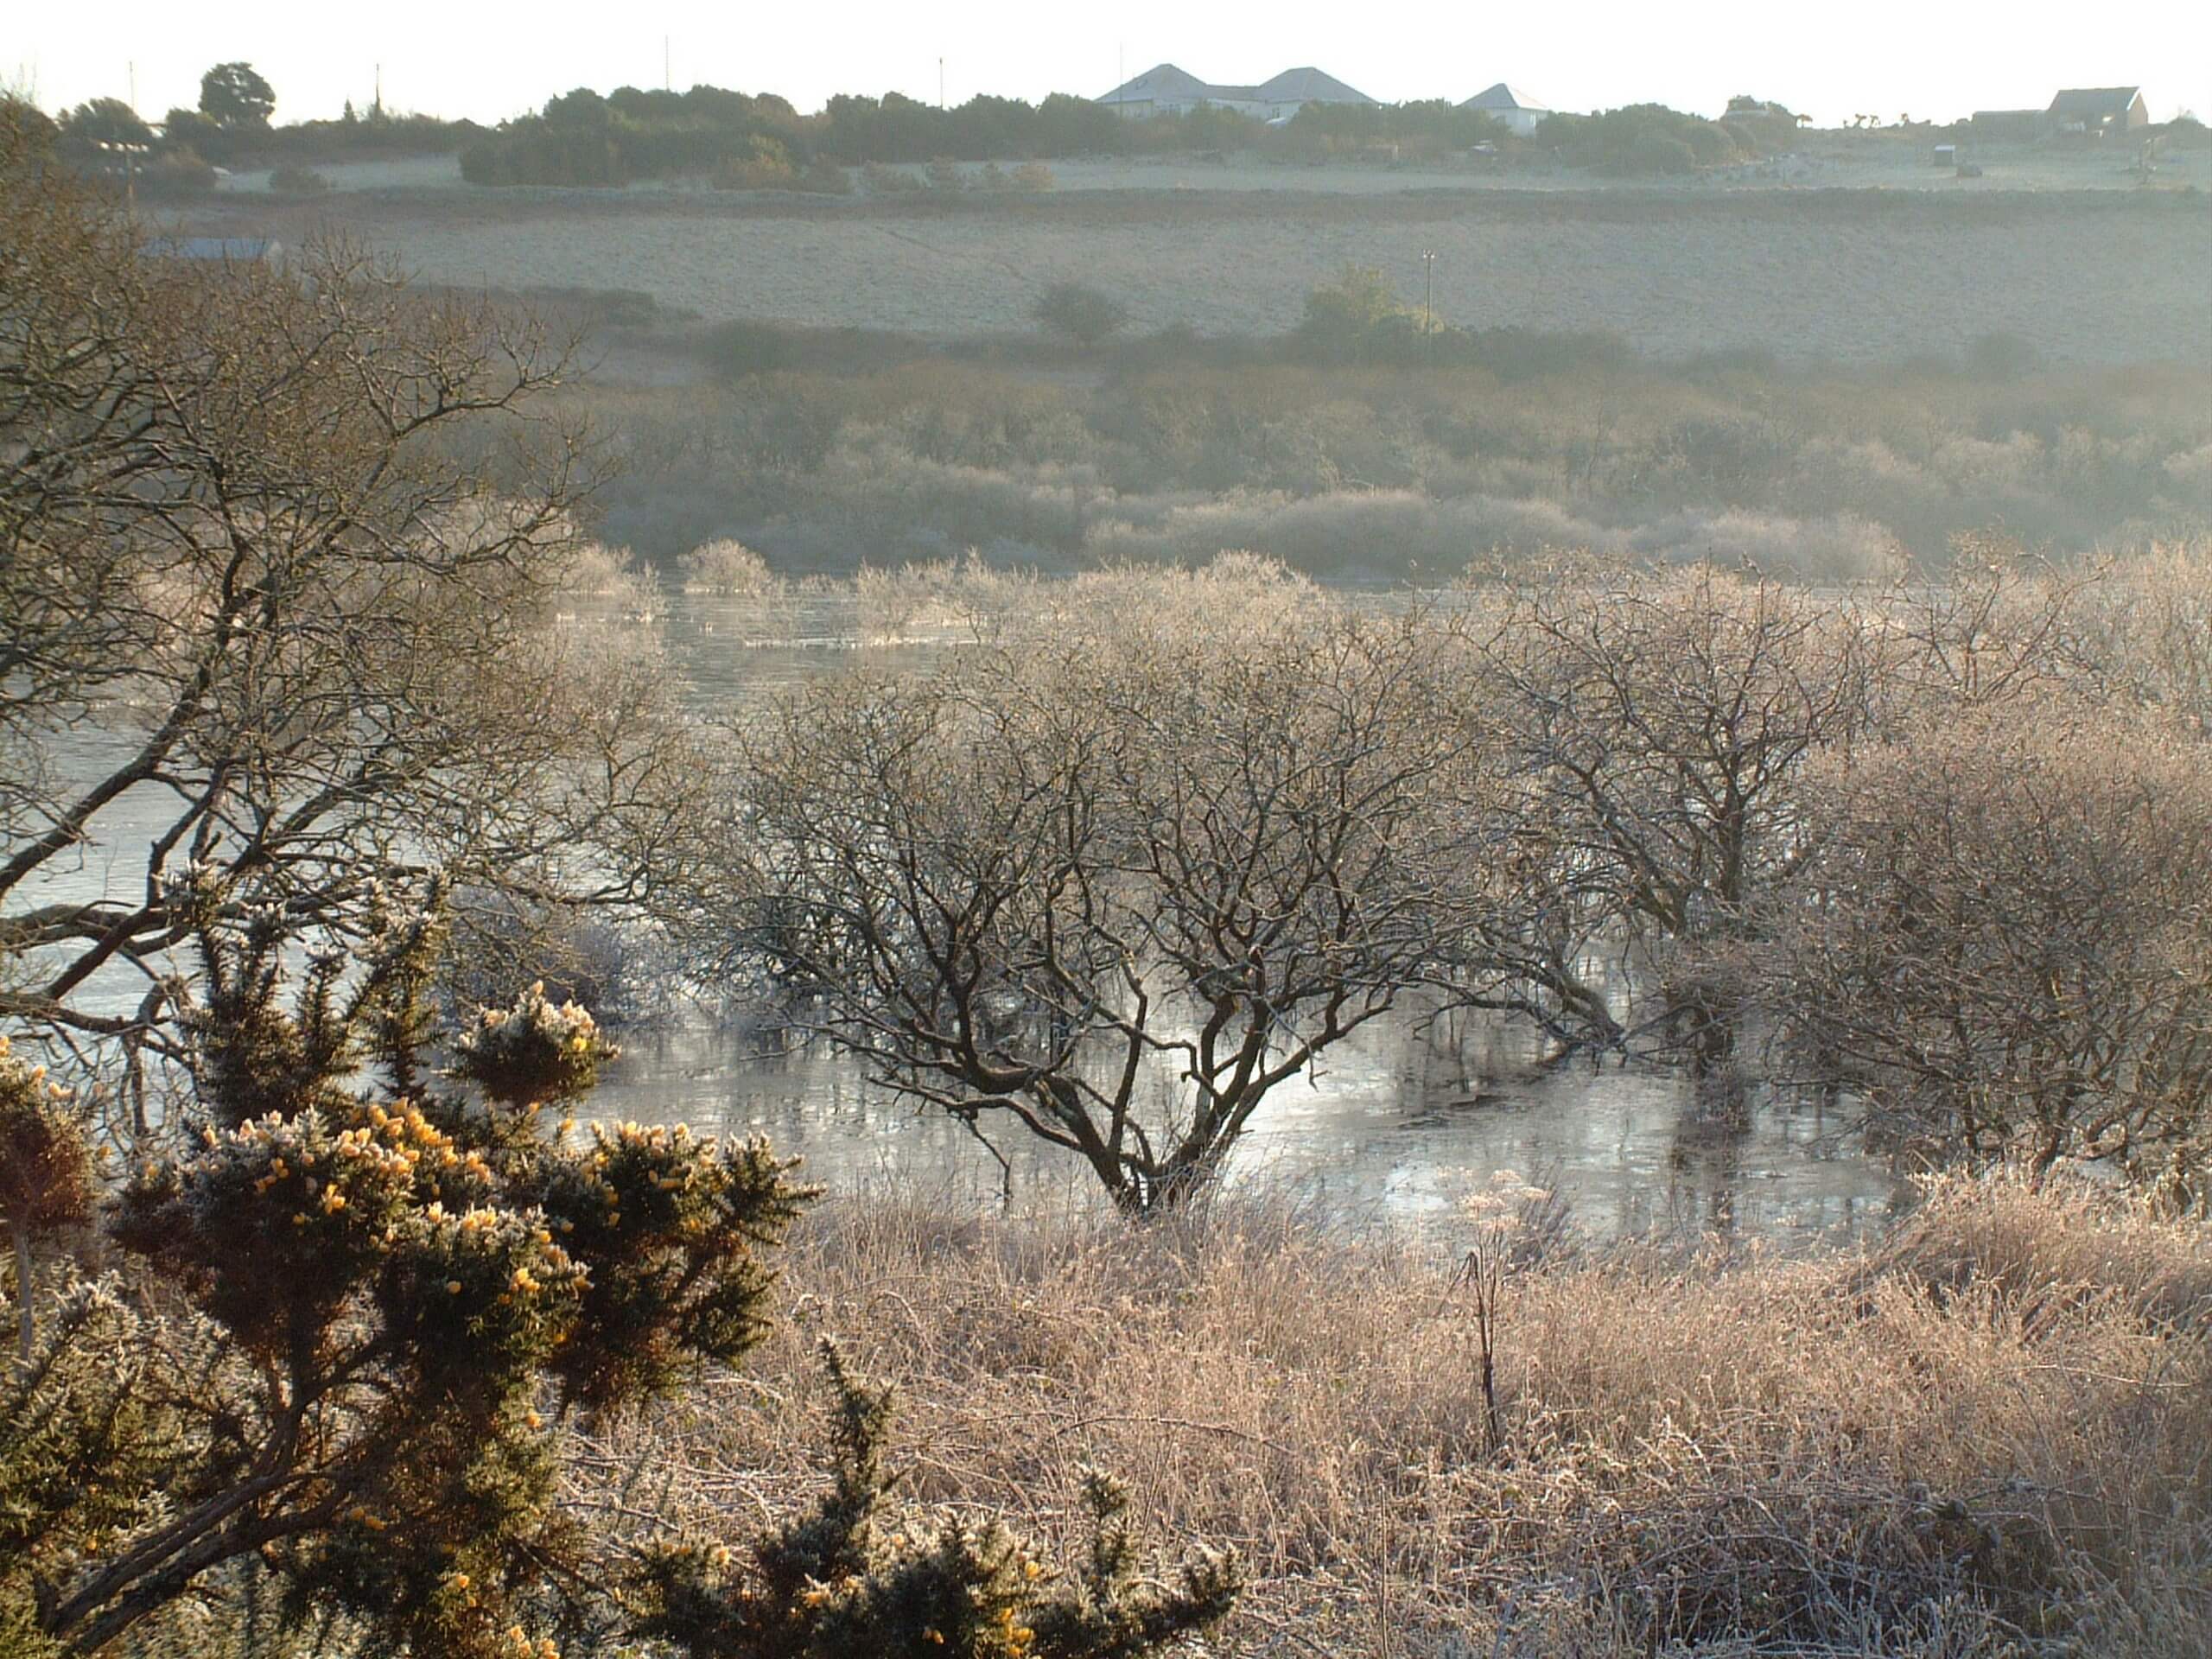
(1466, 564, 1880, 1059)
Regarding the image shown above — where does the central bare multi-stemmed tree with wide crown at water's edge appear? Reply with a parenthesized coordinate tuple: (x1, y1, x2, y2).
(702, 573, 1493, 1212)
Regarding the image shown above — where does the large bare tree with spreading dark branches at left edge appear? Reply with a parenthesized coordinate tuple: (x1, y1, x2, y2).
(0, 119, 703, 1119)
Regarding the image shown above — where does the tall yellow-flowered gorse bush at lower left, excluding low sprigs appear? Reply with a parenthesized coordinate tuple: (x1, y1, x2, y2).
(9, 892, 803, 1655)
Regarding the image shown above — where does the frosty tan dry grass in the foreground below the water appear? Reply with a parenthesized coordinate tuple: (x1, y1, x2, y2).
(570, 1185, 2212, 1659)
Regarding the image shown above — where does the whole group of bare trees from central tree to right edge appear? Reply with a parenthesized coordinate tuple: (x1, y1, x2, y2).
(659, 546, 2212, 1210)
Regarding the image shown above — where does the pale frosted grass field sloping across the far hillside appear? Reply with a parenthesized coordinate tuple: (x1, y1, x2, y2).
(211, 188, 2212, 363)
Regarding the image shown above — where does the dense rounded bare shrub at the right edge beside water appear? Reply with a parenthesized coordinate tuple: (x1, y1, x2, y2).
(1767, 702, 2212, 1192)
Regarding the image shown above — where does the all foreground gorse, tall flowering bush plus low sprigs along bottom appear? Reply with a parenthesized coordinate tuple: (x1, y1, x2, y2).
(0, 887, 1232, 1659)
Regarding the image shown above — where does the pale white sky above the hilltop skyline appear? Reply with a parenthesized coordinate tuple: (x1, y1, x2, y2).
(17, 0, 2212, 124)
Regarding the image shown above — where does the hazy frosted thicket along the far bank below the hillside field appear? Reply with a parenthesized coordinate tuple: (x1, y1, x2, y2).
(584, 340, 2212, 582)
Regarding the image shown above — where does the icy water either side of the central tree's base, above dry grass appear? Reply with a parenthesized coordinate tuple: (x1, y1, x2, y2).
(593, 1022, 1909, 1245)
